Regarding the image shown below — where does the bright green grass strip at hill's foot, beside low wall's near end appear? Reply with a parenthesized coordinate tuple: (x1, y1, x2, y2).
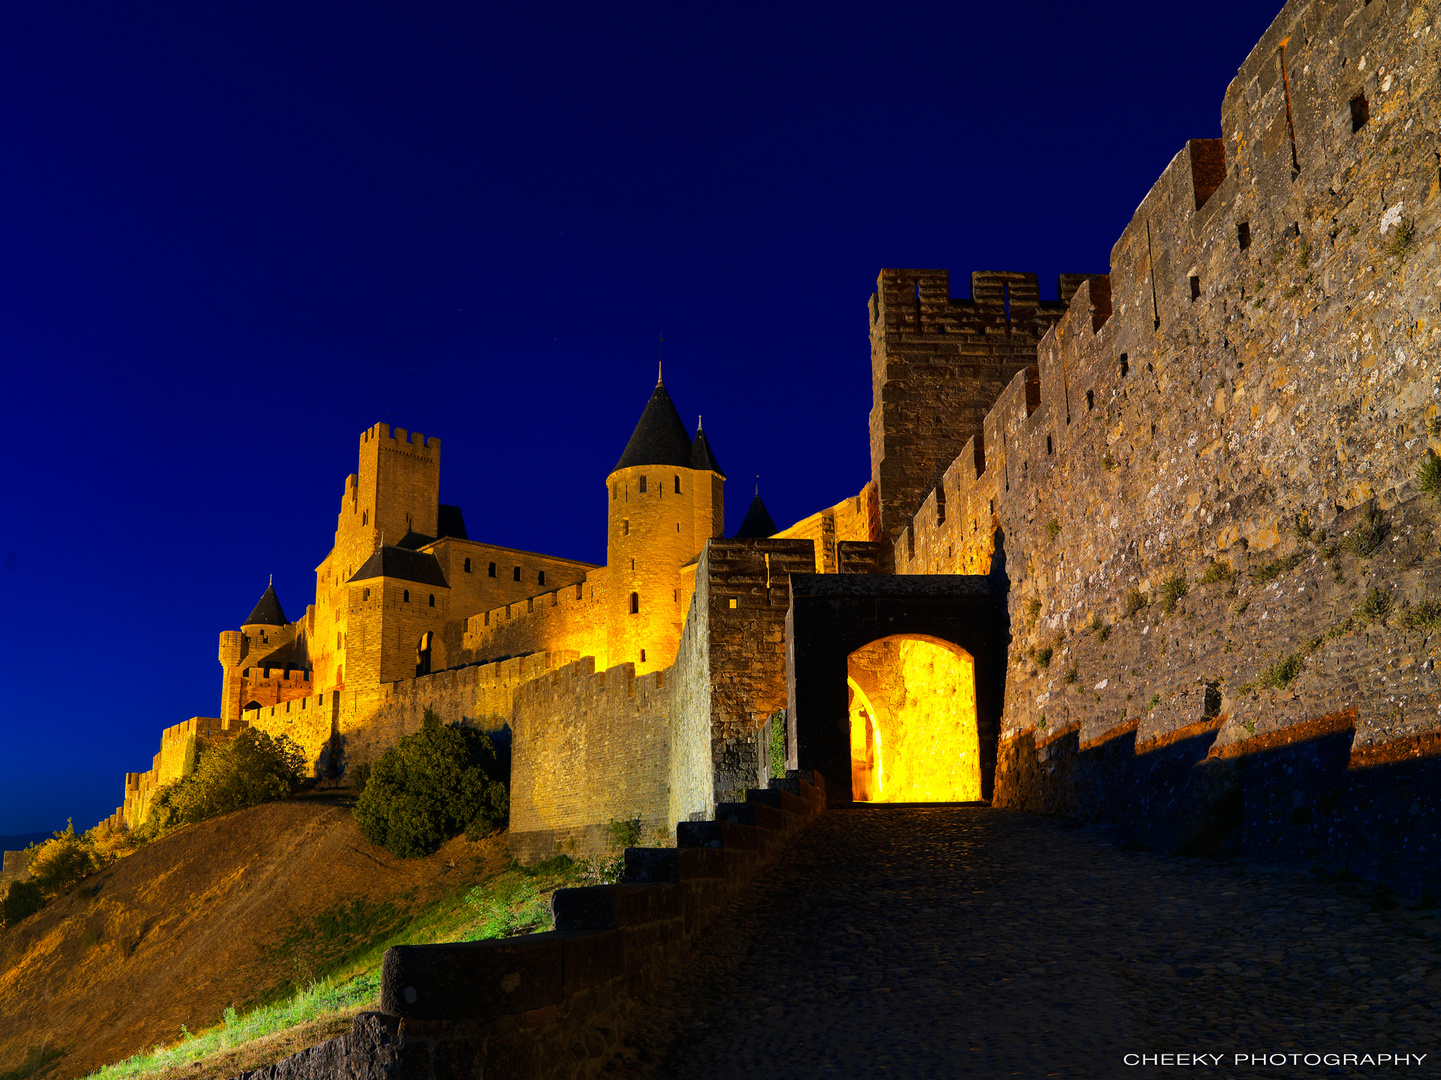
(87, 969, 380, 1080)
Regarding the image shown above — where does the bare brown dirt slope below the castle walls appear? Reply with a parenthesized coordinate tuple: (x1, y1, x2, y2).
(0, 796, 504, 1080)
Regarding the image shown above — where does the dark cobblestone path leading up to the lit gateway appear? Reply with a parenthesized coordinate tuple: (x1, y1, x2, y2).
(612, 807, 1441, 1080)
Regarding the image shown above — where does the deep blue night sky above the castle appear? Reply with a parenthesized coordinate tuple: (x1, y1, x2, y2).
(0, 0, 1280, 833)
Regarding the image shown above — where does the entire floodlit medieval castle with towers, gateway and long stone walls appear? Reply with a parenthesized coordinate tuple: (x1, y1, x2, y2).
(101, 0, 1441, 881)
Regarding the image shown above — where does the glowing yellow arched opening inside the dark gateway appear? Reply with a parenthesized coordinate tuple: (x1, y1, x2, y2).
(846, 636, 981, 803)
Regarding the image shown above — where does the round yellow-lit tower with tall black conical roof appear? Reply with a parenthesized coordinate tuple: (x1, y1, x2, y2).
(605, 378, 725, 673)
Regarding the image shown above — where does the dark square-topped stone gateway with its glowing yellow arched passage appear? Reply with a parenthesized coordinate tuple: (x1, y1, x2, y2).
(785, 574, 1010, 805)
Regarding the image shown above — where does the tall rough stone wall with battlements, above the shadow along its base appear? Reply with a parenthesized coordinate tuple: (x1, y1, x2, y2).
(873, 0, 1441, 876)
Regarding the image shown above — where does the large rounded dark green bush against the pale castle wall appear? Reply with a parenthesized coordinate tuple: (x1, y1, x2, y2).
(354, 725, 510, 858)
